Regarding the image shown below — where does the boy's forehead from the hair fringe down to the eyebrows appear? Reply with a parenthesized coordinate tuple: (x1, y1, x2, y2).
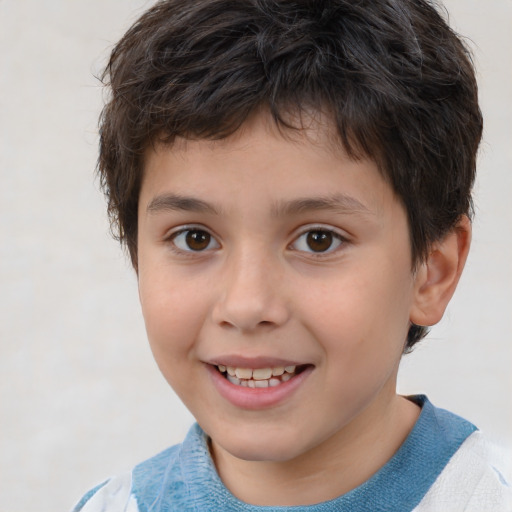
(140, 114, 391, 221)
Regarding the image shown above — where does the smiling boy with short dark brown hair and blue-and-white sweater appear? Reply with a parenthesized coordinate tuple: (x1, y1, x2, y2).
(75, 0, 511, 512)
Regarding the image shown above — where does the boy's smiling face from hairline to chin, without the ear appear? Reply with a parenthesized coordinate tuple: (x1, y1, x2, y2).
(138, 115, 415, 461)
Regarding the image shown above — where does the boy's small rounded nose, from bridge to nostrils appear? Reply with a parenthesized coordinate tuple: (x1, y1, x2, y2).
(213, 248, 289, 332)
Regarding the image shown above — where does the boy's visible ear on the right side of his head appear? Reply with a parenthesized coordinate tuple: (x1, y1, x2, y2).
(410, 215, 471, 326)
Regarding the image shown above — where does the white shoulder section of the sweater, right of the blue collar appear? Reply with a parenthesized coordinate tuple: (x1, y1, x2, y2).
(415, 431, 512, 512)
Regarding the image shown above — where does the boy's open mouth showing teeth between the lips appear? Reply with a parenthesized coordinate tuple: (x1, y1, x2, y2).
(216, 364, 308, 389)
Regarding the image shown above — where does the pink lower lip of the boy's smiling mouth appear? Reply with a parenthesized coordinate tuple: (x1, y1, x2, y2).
(206, 364, 313, 410)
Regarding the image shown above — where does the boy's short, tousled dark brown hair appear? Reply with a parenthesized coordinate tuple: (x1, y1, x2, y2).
(98, 0, 482, 349)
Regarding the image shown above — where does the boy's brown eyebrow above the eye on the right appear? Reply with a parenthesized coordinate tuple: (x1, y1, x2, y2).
(272, 194, 375, 217)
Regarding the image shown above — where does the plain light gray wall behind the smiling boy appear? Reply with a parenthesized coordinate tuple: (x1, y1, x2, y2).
(0, 0, 512, 512)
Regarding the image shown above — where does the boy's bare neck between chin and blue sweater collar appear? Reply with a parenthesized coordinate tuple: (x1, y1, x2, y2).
(211, 394, 420, 506)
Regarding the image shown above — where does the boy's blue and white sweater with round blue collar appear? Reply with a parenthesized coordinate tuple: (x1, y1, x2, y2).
(74, 396, 512, 512)
